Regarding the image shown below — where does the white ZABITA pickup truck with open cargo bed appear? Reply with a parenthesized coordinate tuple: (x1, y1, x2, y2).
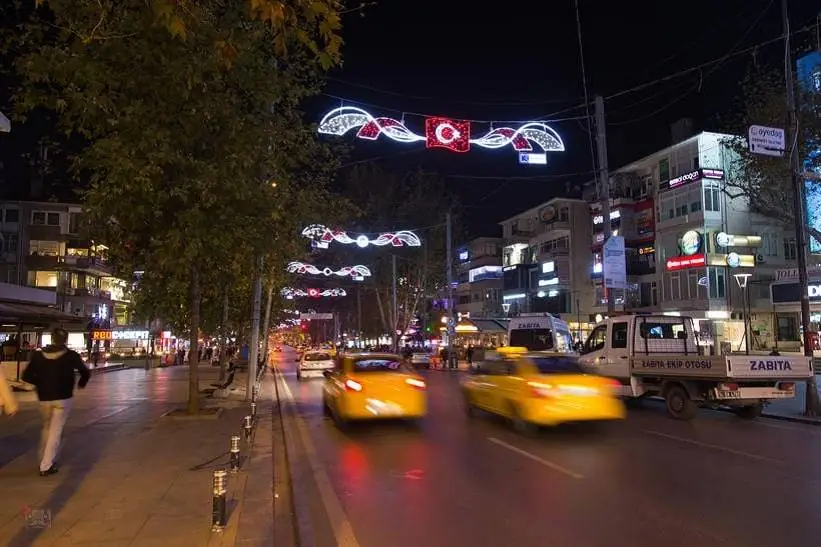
(581, 315, 813, 420)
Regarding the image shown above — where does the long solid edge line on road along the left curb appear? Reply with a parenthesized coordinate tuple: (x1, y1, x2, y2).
(277, 368, 359, 547)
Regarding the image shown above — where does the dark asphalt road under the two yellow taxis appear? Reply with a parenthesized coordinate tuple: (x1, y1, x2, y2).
(277, 352, 821, 547)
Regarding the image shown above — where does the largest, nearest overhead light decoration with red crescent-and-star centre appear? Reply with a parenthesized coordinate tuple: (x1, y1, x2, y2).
(319, 106, 565, 152)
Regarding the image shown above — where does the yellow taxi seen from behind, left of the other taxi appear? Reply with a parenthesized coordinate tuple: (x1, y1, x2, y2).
(322, 353, 428, 426)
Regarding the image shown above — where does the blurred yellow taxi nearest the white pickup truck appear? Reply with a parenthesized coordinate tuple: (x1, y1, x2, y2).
(462, 348, 627, 433)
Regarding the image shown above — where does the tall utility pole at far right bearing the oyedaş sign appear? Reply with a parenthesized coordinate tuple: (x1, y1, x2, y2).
(781, 0, 819, 416)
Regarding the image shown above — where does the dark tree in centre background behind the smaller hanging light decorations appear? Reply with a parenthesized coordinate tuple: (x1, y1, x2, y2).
(336, 165, 454, 348)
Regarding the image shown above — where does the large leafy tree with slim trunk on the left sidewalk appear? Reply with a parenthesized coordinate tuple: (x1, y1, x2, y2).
(16, 0, 346, 413)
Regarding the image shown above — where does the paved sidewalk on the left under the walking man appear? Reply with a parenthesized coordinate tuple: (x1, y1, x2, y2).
(0, 366, 273, 547)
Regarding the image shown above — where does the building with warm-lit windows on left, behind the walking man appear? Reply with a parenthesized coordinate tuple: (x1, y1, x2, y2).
(0, 201, 130, 328)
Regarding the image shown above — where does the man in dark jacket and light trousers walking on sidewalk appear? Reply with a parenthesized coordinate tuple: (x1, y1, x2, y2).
(22, 329, 91, 477)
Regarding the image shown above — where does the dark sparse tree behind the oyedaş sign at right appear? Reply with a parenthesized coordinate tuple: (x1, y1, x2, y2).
(724, 63, 821, 242)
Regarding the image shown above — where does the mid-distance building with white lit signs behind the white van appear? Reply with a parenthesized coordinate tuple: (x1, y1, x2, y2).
(500, 198, 596, 337)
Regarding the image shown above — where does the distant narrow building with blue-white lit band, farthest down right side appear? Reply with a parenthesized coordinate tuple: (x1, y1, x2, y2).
(454, 237, 503, 318)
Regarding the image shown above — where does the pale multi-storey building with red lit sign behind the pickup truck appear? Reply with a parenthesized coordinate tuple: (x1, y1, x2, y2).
(587, 132, 800, 351)
